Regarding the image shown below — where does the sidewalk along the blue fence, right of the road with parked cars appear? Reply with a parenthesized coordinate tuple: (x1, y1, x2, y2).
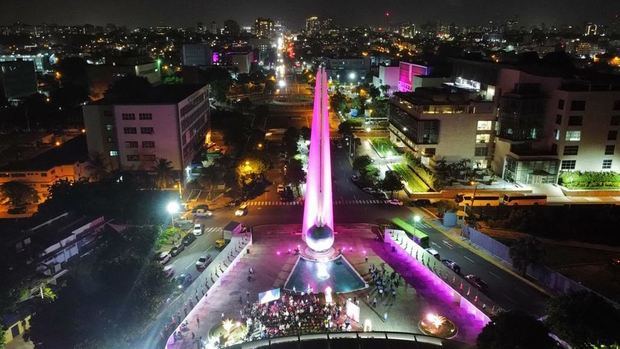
(410, 207, 553, 297)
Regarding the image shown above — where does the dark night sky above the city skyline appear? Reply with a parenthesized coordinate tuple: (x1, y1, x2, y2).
(0, 0, 620, 28)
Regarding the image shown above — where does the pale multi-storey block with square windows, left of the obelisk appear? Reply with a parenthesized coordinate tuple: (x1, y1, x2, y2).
(83, 85, 209, 175)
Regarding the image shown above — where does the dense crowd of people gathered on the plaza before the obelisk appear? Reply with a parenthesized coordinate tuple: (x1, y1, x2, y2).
(240, 292, 351, 341)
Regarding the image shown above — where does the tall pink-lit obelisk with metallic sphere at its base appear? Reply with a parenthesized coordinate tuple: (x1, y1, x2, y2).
(302, 67, 334, 252)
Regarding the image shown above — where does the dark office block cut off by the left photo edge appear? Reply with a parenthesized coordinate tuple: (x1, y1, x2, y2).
(0, 61, 37, 100)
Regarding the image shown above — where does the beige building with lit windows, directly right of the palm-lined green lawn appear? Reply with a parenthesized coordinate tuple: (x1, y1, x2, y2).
(389, 88, 496, 168)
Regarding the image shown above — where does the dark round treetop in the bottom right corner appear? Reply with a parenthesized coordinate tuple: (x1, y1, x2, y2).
(545, 291, 620, 349)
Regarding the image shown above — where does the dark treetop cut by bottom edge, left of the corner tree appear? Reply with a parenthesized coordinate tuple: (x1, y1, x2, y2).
(477, 310, 556, 349)
